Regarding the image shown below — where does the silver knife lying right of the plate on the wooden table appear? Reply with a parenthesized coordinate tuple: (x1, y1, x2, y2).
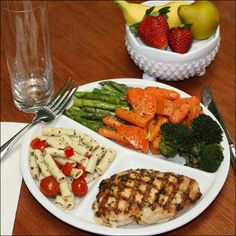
(202, 86, 236, 172)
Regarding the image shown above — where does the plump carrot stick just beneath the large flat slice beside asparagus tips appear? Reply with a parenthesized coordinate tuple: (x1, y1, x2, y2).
(115, 107, 148, 128)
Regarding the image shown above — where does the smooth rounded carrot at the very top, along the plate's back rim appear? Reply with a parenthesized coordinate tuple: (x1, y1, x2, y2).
(145, 86, 180, 101)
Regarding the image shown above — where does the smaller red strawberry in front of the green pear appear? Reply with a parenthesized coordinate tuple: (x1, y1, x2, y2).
(169, 27, 193, 54)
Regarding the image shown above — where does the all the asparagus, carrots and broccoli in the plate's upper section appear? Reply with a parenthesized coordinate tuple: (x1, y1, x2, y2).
(65, 81, 223, 172)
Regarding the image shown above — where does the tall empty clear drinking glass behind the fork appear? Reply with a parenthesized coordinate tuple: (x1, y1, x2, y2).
(1, 1, 53, 113)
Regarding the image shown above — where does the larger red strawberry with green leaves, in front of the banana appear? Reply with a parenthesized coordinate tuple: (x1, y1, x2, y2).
(138, 7, 169, 49)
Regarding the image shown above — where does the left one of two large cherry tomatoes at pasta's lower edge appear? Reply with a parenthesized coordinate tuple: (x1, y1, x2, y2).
(40, 175, 60, 197)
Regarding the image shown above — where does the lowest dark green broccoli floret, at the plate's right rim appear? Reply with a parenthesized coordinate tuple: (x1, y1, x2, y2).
(198, 143, 224, 172)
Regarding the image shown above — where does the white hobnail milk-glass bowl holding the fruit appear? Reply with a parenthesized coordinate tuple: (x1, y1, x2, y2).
(125, 1, 220, 81)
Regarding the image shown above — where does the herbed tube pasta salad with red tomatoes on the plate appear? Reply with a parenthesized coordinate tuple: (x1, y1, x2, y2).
(29, 127, 116, 210)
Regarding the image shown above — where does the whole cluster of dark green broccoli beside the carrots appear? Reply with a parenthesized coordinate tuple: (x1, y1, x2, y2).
(160, 114, 224, 172)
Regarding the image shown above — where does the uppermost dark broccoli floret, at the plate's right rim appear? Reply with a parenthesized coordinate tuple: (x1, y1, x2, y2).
(191, 114, 223, 145)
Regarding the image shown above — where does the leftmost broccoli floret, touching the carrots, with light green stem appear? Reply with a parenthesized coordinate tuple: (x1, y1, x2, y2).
(160, 122, 194, 157)
